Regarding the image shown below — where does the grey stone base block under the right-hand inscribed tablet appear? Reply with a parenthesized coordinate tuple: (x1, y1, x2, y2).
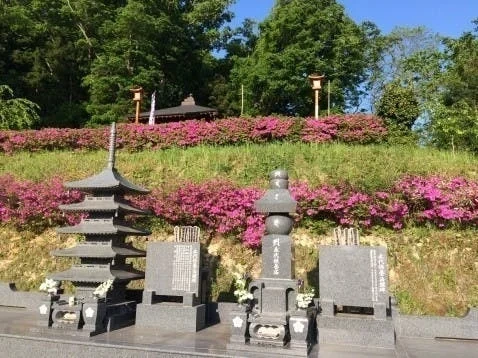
(317, 314, 395, 348)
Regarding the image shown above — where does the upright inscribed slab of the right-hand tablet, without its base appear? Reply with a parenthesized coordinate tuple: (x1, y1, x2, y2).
(319, 246, 389, 307)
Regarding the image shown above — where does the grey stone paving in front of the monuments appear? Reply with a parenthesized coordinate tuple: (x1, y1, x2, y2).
(0, 307, 478, 358)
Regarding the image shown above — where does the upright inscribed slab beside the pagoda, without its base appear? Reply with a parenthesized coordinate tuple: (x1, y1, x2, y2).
(145, 242, 201, 296)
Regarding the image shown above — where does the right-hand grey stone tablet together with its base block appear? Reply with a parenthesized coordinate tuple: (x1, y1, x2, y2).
(317, 245, 395, 348)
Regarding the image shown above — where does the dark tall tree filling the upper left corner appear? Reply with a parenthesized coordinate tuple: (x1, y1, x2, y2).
(0, 0, 121, 126)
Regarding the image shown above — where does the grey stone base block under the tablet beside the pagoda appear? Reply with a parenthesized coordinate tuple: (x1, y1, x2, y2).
(136, 302, 206, 332)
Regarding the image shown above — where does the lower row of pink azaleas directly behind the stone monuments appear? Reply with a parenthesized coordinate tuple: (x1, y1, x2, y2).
(0, 175, 478, 247)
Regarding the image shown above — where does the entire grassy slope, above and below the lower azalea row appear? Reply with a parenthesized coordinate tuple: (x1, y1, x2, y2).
(0, 143, 478, 315)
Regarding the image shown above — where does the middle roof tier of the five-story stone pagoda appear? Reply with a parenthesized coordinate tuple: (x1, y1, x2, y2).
(56, 219, 151, 236)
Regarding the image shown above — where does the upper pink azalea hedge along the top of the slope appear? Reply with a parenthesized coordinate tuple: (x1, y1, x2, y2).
(0, 114, 387, 153)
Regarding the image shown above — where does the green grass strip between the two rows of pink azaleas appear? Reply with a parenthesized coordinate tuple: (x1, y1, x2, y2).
(0, 143, 478, 193)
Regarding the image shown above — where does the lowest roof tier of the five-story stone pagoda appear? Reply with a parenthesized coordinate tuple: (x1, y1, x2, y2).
(49, 264, 144, 283)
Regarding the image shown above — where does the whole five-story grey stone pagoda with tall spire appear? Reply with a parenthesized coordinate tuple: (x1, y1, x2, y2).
(49, 123, 150, 336)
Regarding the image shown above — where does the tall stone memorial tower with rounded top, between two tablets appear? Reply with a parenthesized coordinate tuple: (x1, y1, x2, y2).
(228, 170, 316, 356)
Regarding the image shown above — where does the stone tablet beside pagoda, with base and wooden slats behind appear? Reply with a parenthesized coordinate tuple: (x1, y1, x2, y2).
(136, 226, 206, 332)
